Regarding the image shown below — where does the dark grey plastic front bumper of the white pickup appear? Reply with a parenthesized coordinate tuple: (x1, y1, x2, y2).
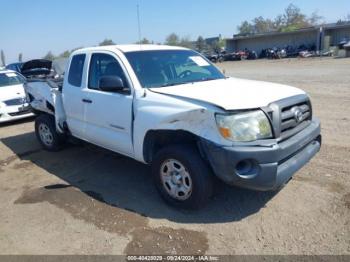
(201, 119, 321, 191)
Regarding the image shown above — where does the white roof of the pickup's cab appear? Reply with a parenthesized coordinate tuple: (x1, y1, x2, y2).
(75, 44, 187, 53)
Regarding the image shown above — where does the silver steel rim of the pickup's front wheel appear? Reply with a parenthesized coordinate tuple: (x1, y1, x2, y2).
(160, 159, 192, 201)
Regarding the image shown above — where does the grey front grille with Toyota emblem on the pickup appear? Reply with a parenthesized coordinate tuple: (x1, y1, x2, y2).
(268, 95, 312, 140)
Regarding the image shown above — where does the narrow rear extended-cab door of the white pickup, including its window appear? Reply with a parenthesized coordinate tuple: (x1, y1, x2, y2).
(62, 54, 87, 139)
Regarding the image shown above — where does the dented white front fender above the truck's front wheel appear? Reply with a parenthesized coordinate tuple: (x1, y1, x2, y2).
(133, 92, 232, 162)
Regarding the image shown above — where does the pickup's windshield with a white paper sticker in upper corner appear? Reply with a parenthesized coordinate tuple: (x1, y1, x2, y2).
(125, 50, 225, 88)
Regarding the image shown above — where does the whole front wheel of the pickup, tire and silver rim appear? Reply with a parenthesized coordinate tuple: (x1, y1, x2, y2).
(152, 145, 213, 209)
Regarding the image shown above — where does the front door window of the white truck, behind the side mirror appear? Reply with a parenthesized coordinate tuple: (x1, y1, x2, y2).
(89, 54, 128, 89)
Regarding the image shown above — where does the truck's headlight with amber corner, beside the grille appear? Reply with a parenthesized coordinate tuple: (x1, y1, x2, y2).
(216, 110, 273, 142)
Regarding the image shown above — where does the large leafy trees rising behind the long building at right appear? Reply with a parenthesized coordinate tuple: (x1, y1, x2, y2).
(238, 4, 323, 35)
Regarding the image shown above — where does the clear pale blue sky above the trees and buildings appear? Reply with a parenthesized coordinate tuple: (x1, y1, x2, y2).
(0, 0, 350, 63)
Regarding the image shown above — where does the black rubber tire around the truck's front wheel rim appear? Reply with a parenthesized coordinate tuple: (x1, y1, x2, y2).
(152, 145, 213, 209)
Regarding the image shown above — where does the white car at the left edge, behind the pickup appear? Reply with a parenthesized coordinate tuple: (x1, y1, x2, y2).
(0, 70, 33, 123)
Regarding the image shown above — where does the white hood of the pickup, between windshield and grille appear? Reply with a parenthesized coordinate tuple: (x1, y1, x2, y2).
(150, 78, 305, 110)
